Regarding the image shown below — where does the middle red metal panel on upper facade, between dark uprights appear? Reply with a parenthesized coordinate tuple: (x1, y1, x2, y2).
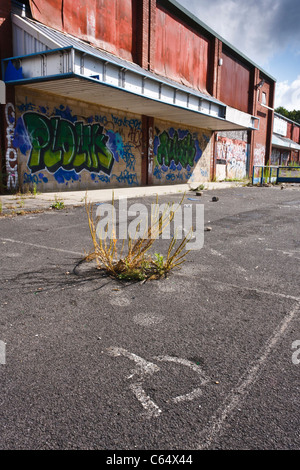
(154, 7, 209, 91)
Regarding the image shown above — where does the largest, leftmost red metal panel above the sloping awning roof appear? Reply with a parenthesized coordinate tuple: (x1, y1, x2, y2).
(30, 0, 137, 60)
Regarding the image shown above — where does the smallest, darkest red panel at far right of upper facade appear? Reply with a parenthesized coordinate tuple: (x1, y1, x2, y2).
(220, 52, 250, 113)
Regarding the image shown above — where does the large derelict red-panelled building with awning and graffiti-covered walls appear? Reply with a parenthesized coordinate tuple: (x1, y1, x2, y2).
(0, 0, 275, 191)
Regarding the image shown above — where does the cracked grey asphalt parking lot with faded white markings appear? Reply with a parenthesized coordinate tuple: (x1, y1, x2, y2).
(0, 186, 300, 450)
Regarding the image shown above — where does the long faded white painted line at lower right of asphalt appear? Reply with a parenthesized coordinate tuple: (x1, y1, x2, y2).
(198, 304, 300, 450)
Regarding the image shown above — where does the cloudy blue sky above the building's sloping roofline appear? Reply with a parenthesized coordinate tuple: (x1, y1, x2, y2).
(177, 0, 300, 110)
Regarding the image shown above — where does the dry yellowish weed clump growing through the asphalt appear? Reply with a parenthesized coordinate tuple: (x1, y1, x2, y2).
(84, 195, 192, 282)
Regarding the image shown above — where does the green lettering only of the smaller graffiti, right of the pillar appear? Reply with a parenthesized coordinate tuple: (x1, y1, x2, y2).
(154, 128, 202, 170)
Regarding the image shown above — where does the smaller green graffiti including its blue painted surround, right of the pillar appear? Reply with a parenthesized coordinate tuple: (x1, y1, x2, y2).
(153, 128, 209, 182)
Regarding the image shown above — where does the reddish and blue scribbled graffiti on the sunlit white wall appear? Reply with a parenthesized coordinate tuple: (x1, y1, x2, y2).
(216, 137, 247, 178)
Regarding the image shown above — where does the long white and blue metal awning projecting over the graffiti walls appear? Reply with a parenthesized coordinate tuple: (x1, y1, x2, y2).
(2, 15, 259, 131)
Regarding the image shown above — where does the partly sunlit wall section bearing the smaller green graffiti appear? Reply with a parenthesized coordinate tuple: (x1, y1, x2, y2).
(152, 119, 212, 185)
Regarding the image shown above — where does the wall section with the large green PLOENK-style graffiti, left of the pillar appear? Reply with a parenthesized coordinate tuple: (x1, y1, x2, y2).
(12, 88, 142, 192)
